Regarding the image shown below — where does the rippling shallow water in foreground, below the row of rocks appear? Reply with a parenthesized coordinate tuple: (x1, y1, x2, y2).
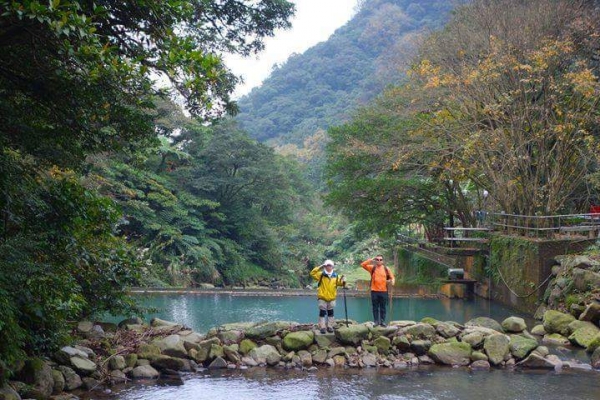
(104, 367, 600, 400)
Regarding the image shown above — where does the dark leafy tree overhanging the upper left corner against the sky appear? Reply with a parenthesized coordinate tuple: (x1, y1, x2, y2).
(0, 0, 294, 165)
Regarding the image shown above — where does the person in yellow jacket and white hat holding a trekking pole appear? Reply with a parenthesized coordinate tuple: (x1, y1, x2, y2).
(310, 260, 346, 333)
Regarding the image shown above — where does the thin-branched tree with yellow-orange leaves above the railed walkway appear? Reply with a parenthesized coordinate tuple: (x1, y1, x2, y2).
(414, 0, 600, 215)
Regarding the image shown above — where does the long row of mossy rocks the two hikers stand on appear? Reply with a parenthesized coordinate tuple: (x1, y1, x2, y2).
(0, 311, 600, 399)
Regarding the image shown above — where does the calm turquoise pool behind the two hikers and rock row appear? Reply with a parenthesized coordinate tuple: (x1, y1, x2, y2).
(129, 294, 527, 333)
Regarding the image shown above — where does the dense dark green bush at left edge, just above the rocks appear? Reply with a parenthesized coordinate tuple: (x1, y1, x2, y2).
(0, 151, 138, 378)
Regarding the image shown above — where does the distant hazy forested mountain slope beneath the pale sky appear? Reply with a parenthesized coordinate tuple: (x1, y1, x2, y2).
(237, 0, 456, 147)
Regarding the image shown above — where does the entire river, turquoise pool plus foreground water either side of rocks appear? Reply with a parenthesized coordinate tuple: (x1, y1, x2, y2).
(101, 294, 600, 400)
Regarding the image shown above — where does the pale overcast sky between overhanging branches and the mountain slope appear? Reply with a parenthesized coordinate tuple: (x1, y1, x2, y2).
(225, 0, 357, 98)
